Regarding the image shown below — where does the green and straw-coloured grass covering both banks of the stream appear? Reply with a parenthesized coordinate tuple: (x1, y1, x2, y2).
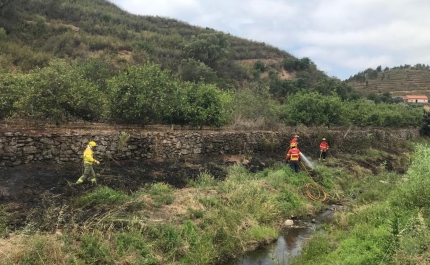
(4, 144, 430, 265)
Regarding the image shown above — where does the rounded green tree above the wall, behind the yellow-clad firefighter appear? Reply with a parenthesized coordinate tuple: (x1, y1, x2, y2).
(16, 61, 105, 122)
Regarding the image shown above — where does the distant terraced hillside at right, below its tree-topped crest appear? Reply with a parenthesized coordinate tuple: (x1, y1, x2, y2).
(348, 68, 430, 97)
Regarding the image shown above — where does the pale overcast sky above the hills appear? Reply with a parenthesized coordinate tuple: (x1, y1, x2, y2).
(110, 0, 430, 80)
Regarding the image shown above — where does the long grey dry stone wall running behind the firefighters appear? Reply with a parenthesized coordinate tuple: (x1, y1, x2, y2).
(0, 129, 419, 167)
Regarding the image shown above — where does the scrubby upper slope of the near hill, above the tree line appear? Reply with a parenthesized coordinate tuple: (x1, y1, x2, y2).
(0, 0, 325, 88)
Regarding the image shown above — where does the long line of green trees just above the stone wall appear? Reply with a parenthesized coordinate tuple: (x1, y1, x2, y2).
(0, 58, 423, 127)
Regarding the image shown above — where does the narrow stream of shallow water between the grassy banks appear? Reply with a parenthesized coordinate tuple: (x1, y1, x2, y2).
(222, 205, 342, 265)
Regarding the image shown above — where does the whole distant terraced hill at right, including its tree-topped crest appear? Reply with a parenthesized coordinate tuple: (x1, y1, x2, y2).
(346, 64, 430, 97)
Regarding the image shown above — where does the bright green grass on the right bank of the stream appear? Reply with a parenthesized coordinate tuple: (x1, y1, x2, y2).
(291, 144, 430, 265)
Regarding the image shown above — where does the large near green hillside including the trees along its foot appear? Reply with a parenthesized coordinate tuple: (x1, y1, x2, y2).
(0, 0, 422, 128)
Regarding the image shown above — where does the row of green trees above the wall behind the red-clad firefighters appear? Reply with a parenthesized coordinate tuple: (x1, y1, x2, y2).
(281, 92, 422, 127)
